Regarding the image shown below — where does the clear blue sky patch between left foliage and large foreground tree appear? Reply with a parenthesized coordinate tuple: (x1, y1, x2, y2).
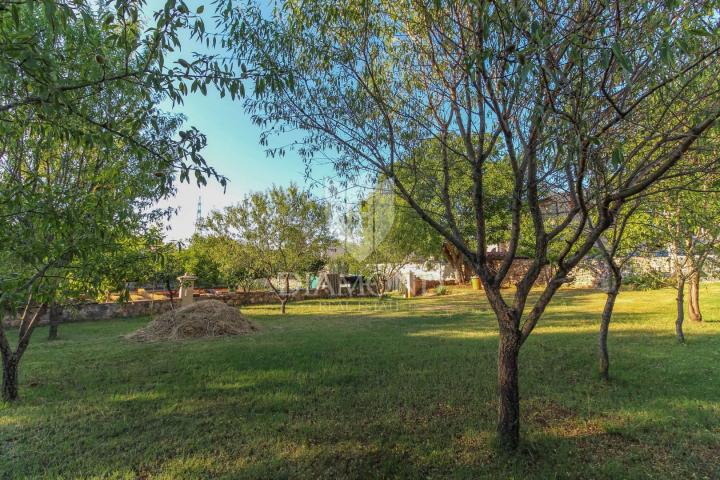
(146, 0, 338, 240)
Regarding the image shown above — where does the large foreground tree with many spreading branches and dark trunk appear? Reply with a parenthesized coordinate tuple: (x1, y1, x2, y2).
(231, 0, 720, 450)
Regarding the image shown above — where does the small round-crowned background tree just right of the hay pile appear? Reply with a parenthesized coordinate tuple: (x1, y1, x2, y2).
(207, 185, 330, 314)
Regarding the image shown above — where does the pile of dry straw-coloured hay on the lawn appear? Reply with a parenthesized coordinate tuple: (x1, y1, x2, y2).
(125, 300, 257, 342)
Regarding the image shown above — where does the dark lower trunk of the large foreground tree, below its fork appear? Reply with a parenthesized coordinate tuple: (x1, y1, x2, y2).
(498, 326, 520, 451)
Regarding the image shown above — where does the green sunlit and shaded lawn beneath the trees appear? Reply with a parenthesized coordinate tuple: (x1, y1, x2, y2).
(0, 285, 720, 479)
